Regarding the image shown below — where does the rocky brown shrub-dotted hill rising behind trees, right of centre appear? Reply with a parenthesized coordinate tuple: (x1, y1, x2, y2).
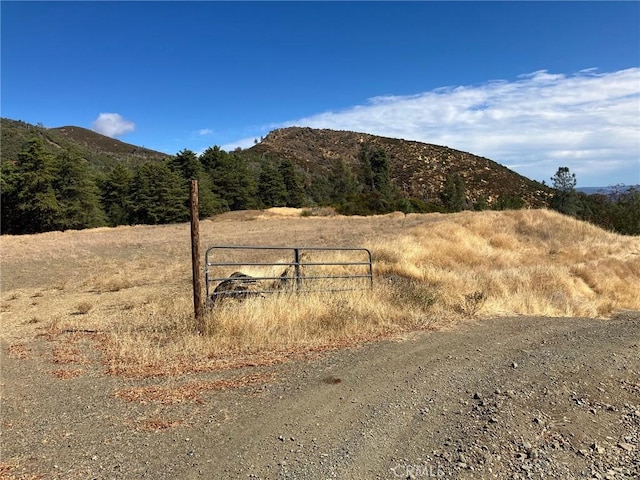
(244, 127, 552, 207)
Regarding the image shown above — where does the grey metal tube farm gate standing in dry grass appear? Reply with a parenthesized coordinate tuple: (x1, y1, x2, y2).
(205, 245, 373, 305)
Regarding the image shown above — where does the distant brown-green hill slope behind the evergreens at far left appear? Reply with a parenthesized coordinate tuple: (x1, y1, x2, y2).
(0, 118, 169, 170)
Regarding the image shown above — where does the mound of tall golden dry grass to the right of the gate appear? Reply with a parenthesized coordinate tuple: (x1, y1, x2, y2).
(372, 210, 640, 318)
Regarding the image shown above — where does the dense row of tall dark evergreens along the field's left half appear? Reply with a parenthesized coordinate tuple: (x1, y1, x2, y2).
(1, 139, 306, 234)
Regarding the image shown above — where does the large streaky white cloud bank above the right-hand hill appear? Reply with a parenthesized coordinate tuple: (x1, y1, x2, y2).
(245, 68, 640, 185)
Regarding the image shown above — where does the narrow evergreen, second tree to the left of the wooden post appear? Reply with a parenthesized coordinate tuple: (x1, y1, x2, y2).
(101, 163, 133, 226)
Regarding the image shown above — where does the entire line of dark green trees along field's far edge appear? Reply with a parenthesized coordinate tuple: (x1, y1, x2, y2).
(1, 139, 640, 235)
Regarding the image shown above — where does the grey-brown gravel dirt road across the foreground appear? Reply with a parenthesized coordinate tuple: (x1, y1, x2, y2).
(0, 313, 640, 479)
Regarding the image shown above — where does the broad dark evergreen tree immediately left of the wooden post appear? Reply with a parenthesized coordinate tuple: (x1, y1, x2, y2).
(131, 162, 189, 225)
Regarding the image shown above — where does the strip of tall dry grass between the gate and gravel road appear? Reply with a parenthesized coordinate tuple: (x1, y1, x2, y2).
(100, 272, 434, 376)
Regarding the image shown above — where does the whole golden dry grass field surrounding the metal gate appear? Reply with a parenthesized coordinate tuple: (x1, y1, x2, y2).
(0, 209, 640, 378)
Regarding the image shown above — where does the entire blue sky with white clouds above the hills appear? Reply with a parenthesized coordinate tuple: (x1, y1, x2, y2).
(0, 1, 640, 186)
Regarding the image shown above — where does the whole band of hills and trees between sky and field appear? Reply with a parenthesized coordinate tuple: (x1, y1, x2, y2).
(1, 119, 640, 234)
